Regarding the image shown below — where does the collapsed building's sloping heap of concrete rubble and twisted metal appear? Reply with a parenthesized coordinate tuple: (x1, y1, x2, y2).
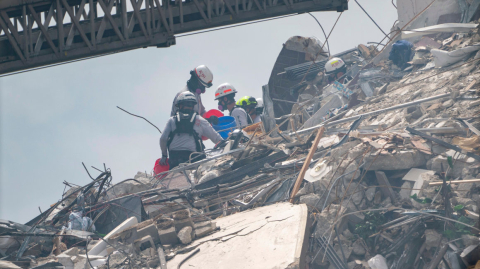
(0, 1, 480, 269)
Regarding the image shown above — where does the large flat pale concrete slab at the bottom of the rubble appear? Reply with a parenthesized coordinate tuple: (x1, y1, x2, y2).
(167, 203, 309, 269)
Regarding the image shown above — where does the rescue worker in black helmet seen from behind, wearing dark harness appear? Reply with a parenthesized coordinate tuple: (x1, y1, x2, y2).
(160, 92, 223, 169)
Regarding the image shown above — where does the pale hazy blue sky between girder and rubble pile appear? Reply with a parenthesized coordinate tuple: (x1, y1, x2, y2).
(0, 0, 397, 223)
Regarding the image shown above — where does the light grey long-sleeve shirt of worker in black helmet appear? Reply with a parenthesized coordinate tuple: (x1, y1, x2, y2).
(160, 115, 223, 156)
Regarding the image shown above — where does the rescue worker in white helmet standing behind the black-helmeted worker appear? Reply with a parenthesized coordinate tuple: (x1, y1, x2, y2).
(170, 65, 213, 117)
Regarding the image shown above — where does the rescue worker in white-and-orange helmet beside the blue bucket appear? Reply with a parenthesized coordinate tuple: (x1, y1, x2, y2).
(215, 83, 253, 128)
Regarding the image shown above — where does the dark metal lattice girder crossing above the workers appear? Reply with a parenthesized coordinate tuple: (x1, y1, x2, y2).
(0, 0, 348, 74)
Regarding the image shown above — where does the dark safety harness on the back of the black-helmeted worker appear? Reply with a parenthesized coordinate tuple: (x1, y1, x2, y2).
(167, 112, 205, 152)
